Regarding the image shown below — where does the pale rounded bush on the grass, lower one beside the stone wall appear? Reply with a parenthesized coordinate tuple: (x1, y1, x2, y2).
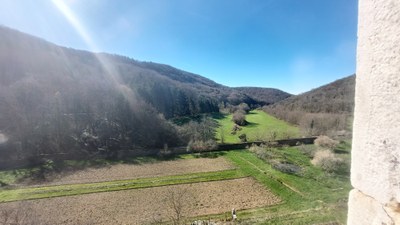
(311, 150, 348, 173)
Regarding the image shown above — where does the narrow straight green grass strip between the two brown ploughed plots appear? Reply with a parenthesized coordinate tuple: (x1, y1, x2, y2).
(0, 169, 246, 202)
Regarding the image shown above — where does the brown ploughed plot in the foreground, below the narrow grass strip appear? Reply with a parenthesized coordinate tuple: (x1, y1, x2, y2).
(0, 178, 280, 224)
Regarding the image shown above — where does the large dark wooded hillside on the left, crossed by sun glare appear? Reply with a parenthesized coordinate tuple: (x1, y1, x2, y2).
(0, 26, 285, 160)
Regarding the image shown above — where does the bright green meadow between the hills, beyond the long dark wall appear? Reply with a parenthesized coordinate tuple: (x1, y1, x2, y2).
(216, 110, 300, 143)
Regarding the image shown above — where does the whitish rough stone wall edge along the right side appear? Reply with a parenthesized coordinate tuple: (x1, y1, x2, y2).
(348, 0, 400, 222)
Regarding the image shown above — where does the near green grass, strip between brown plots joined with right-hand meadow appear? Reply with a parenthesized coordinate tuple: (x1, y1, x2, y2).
(0, 149, 351, 224)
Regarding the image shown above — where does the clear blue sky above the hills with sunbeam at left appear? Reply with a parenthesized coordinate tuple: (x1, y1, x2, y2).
(0, 0, 357, 94)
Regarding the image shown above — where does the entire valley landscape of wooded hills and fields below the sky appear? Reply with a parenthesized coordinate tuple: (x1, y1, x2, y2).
(0, 27, 354, 225)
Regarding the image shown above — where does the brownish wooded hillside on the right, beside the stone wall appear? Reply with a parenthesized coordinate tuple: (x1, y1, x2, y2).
(264, 75, 355, 135)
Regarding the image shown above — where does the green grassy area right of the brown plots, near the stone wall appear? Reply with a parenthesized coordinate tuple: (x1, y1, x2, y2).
(225, 148, 351, 224)
